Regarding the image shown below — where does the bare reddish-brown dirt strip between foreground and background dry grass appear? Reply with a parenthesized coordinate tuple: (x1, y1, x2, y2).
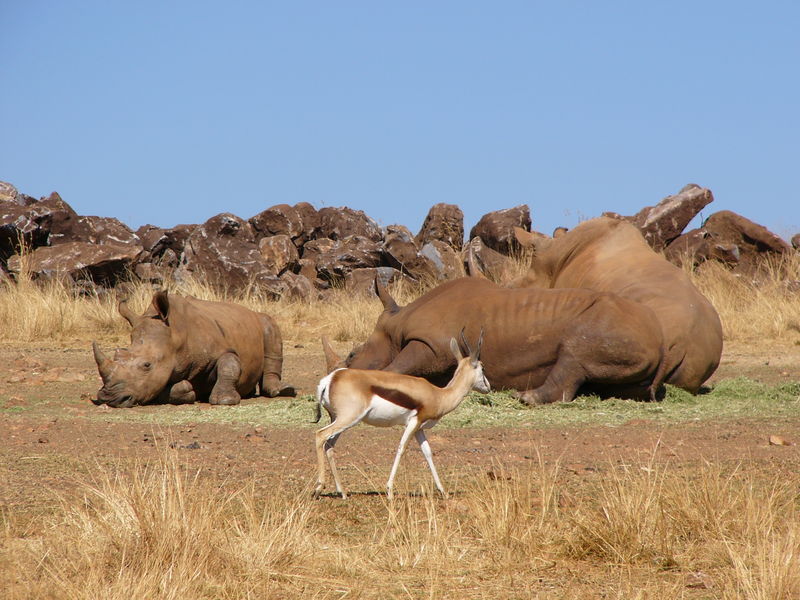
(0, 342, 800, 513)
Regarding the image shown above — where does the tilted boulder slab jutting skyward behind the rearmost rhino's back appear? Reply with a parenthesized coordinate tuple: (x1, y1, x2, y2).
(627, 183, 714, 252)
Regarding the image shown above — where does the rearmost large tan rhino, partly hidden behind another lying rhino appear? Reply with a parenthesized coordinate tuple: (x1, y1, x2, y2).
(516, 217, 722, 393)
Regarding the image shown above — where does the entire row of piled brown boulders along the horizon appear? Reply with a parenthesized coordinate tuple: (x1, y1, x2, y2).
(0, 182, 800, 299)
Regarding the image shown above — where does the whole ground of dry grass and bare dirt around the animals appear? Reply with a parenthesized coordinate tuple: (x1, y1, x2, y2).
(0, 255, 800, 600)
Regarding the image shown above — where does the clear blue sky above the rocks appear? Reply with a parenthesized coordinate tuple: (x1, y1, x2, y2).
(0, 0, 800, 236)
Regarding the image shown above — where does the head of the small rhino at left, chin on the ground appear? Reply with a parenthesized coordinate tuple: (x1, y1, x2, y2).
(92, 292, 176, 408)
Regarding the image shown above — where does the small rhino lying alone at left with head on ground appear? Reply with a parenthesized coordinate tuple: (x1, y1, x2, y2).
(92, 292, 291, 407)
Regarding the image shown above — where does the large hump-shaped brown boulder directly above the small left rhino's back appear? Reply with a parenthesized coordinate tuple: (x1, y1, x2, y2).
(175, 213, 278, 295)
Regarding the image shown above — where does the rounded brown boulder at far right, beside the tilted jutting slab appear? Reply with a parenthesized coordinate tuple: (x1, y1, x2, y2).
(703, 210, 791, 273)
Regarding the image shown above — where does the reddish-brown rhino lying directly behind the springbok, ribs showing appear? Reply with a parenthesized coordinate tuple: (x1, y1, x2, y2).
(325, 277, 662, 404)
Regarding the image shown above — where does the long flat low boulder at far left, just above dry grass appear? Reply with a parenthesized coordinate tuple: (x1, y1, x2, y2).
(8, 242, 142, 286)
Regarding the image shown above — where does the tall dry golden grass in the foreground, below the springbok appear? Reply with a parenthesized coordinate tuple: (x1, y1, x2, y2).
(0, 450, 800, 600)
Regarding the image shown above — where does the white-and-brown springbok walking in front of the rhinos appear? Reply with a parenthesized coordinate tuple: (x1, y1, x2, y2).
(314, 331, 490, 499)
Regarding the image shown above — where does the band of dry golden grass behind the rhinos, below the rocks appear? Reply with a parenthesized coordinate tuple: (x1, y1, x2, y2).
(0, 254, 800, 342)
